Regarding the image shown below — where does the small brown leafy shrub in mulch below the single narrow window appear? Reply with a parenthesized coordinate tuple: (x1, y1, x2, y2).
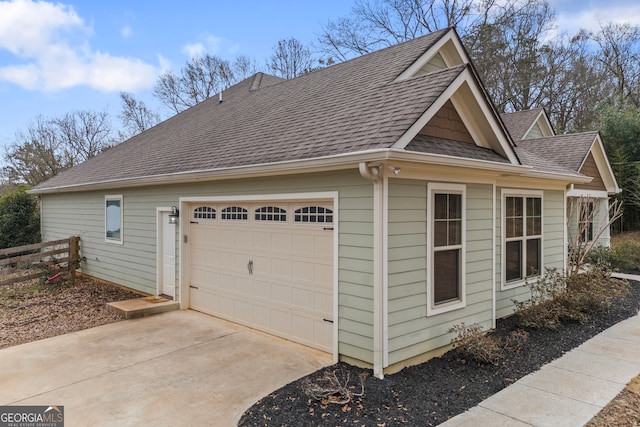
(449, 322, 529, 365)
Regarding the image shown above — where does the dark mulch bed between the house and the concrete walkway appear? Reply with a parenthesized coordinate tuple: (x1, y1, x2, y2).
(239, 282, 640, 427)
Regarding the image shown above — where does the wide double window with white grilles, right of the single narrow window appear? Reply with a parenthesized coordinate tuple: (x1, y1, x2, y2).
(503, 193, 542, 285)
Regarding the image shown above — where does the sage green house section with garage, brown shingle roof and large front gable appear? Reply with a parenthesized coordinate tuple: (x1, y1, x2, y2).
(33, 29, 592, 377)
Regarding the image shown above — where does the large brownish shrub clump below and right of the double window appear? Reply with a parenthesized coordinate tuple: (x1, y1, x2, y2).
(514, 267, 630, 329)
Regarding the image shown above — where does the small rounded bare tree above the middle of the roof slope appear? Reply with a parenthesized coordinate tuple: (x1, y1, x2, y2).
(267, 37, 314, 79)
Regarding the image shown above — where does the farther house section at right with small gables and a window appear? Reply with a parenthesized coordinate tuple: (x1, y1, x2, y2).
(501, 108, 621, 246)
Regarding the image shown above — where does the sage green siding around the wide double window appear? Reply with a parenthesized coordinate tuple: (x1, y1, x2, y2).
(496, 189, 567, 318)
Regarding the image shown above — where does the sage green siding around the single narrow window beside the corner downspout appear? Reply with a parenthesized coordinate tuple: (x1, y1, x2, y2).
(388, 179, 493, 364)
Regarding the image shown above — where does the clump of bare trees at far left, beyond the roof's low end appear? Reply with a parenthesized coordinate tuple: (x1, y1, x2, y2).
(4, 111, 113, 186)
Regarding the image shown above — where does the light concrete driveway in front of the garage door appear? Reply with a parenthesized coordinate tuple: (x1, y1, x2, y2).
(0, 310, 332, 426)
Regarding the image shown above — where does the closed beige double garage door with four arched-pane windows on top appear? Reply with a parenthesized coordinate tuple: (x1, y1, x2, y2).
(189, 201, 333, 352)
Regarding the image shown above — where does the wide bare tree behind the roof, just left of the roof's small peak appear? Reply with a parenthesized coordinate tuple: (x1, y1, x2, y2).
(153, 55, 236, 113)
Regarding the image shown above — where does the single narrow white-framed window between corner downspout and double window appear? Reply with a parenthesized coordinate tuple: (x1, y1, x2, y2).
(427, 184, 465, 315)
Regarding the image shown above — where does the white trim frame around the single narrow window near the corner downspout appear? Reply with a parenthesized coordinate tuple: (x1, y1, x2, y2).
(427, 182, 467, 316)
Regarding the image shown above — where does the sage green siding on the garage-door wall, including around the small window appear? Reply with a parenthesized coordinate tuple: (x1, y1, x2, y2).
(42, 170, 373, 363)
